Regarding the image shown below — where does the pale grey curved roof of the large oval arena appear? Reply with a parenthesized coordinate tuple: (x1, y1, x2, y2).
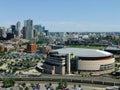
(53, 48, 113, 58)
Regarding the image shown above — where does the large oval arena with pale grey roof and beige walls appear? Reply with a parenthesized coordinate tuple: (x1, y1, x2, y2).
(43, 48, 115, 75)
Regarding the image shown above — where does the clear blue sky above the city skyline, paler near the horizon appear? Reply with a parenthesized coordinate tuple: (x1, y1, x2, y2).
(0, 0, 120, 32)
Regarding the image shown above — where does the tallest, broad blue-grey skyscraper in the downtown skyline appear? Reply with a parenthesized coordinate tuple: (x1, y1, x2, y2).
(24, 19, 34, 40)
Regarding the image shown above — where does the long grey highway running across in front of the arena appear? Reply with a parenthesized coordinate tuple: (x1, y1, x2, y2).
(0, 74, 120, 85)
